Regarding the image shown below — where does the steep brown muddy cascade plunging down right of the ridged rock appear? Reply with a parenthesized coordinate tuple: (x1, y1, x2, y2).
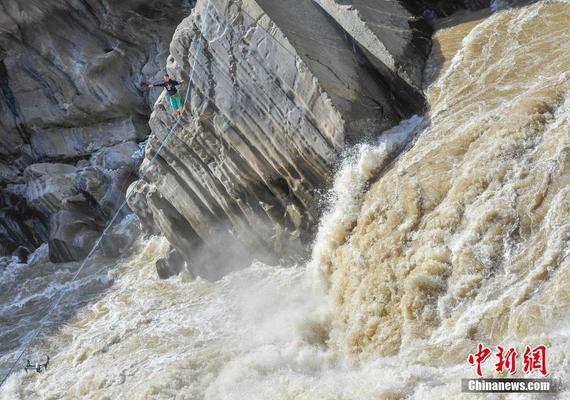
(317, 1, 570, 360)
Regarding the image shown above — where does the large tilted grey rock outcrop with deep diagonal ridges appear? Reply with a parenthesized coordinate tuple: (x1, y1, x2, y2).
(129, 0, 430, 274)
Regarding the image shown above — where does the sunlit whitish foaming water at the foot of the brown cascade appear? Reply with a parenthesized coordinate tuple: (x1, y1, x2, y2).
(0, 238, 474, 399)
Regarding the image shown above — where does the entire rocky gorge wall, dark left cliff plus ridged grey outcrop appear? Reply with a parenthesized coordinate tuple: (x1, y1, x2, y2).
(0, 0, 486, 268)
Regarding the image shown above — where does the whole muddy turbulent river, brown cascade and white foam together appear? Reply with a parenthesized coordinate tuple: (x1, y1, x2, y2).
(0, 1, 570, 400)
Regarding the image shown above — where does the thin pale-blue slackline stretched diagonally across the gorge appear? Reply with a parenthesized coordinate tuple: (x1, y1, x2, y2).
(0, 0, 211, 388)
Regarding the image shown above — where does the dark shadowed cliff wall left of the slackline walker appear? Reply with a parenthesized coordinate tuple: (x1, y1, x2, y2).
(0, 0, 192, 261)
